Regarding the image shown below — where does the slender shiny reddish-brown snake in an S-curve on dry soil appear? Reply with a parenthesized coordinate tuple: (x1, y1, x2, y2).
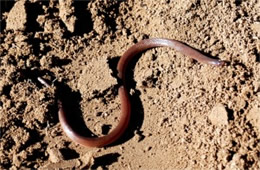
(38, 38, 225, 147)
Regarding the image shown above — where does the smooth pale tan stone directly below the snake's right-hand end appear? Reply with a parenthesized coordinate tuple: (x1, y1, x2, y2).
(209, 104, 228, 126)
